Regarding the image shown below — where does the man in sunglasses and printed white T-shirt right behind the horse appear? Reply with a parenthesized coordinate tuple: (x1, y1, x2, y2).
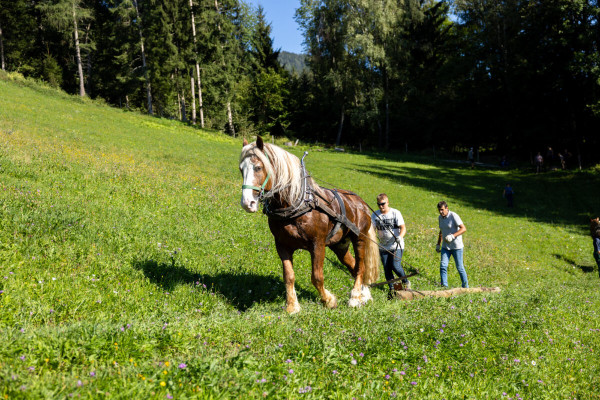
(371, 193, 410, 298)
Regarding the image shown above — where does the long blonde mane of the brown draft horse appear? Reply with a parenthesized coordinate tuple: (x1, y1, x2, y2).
(240, 143, 318, 204)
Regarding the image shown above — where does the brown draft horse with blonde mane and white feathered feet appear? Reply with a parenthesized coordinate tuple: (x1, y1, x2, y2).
(240, 136, 379, 314)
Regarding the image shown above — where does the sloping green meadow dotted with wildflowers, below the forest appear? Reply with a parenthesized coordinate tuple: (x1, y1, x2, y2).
(0, 74, 600, 399)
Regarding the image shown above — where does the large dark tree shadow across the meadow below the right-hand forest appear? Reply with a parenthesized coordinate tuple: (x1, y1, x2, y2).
(352, 163, 600, 232)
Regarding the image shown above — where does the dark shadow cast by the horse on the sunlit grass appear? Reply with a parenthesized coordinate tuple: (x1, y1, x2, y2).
(132, 260, 318, 311)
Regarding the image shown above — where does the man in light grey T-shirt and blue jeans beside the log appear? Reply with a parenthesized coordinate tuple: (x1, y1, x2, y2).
(435, 201, 469, 288)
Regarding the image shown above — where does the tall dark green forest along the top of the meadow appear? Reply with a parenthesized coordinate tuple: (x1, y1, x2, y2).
(0, 0, 600, 165)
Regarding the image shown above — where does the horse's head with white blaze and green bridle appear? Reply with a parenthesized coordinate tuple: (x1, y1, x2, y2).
(240, 136, 273, 212)
